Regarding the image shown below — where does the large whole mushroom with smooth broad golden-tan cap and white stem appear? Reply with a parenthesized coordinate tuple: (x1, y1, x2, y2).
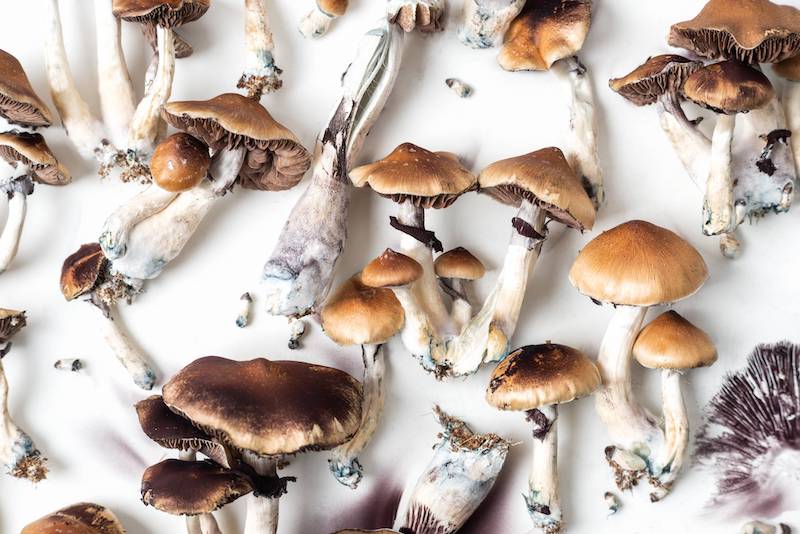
(569, 221, 708, 489)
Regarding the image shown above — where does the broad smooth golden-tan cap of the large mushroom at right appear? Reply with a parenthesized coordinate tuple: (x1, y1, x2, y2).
(569, 221, 708, 306)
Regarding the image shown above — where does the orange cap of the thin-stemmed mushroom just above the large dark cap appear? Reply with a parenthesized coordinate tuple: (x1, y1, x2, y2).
(320, 274, 405, 345)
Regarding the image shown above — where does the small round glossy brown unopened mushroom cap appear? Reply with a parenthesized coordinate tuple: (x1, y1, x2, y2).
(150, 132, 211, 193)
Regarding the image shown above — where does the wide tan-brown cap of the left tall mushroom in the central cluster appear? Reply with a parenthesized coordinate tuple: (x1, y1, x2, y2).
(350, 143, 476, 208)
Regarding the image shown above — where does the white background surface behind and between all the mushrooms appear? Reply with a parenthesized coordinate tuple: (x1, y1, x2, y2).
(0, 0, 800, 534)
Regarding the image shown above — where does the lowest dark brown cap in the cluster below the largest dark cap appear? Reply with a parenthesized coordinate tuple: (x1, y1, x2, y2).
(141, 459, 254, 515)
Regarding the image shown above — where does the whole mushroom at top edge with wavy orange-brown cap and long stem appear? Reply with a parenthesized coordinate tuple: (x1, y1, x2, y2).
(498, 0, 605, 206)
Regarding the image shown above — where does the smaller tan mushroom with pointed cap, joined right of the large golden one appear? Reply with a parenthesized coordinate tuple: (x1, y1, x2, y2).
(633, 310, 717, 502)
